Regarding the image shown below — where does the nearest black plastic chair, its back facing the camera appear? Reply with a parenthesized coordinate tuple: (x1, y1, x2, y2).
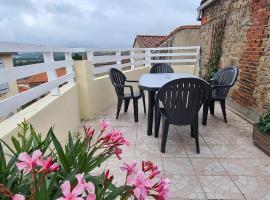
(156, 78, 210, 154)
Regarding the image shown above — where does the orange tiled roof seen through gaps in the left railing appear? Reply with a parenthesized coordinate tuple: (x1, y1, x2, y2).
(17, 68, 67, 85)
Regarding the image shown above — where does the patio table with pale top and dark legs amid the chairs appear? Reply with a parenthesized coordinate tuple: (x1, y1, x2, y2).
(139, 73, 198, 135)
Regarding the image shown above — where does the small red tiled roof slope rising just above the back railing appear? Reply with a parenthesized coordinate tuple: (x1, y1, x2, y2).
(133, 35, 166, 48)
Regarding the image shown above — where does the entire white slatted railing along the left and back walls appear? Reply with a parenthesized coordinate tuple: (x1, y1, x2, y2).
(0, 42, 200, 118)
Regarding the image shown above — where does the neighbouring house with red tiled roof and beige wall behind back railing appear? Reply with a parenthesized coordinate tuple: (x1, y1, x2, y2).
(133, 25, 200, 48)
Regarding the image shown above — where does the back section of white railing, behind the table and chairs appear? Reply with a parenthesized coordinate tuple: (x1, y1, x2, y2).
(85, 46, 200, 75)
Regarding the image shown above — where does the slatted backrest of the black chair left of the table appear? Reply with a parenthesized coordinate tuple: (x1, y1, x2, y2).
(109, 68, 127, 96)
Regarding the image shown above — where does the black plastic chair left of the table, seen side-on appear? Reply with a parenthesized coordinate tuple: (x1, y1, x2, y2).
(109, 68, 146, 122)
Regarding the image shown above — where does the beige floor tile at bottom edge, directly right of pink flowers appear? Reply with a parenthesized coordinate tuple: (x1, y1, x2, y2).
(166, 174, 206, 199)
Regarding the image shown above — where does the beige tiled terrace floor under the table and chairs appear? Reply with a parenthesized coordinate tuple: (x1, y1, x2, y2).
(79, 101, 270, 199)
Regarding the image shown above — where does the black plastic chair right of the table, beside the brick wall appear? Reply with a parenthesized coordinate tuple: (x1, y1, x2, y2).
(202, 66, 239, 125)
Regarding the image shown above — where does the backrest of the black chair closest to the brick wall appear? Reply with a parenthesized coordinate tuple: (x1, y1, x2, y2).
(212, 66, 239, 99)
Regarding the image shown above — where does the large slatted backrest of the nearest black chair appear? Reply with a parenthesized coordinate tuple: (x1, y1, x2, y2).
(157, 78, 210, 125)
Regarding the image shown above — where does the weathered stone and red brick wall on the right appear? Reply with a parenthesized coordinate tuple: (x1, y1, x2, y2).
(201, 0, 270, 120)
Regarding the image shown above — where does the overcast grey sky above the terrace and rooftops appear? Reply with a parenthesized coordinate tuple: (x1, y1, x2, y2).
(0, 0, 200, 48)
